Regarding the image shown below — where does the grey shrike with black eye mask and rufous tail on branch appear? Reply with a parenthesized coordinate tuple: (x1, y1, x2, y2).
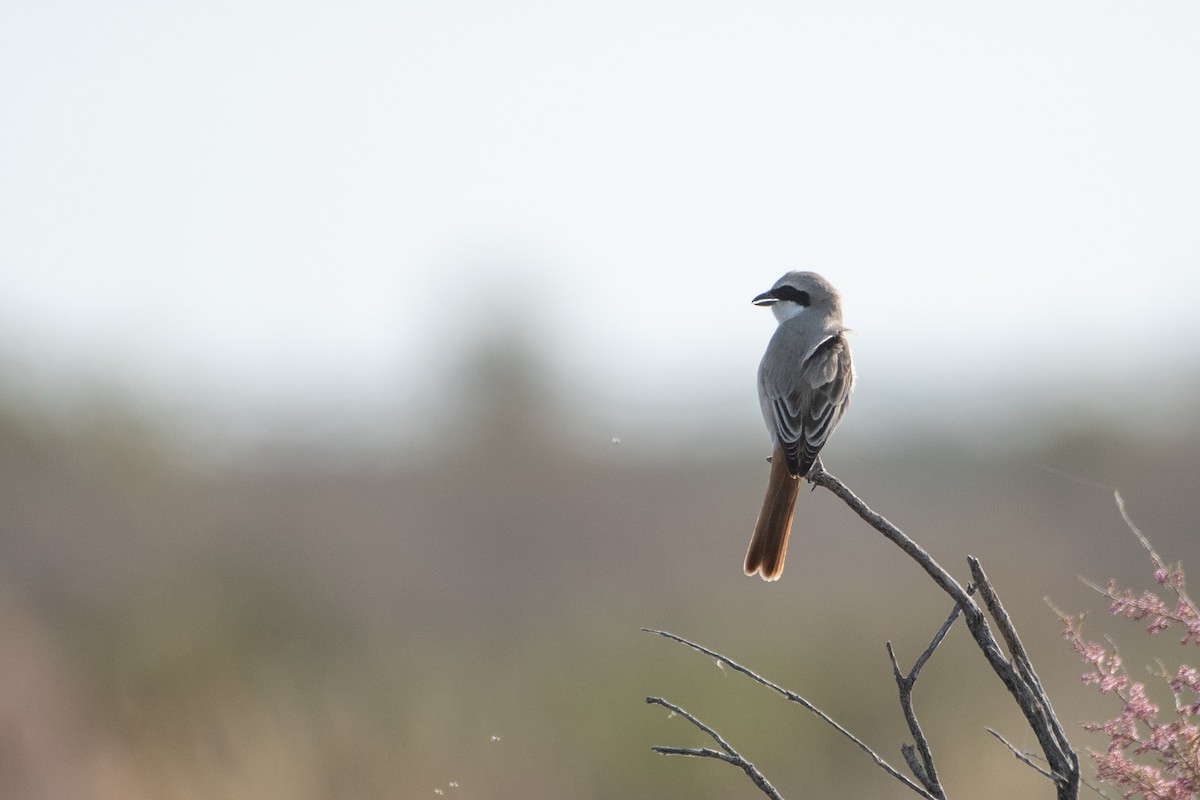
(745, 272, 854, 581)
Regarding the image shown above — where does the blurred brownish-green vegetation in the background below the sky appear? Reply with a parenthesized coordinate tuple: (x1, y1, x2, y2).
(0, 341, 1200, 800)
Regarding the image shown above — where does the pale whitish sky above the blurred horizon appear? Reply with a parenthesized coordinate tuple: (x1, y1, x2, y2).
(0, 0, 1200, 443)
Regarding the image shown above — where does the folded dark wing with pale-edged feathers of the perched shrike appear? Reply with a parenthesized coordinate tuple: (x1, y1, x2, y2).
(769, 331, 854, 477)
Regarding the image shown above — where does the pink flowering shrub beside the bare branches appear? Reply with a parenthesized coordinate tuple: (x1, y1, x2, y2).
(1060, 495, 1200, 800)
